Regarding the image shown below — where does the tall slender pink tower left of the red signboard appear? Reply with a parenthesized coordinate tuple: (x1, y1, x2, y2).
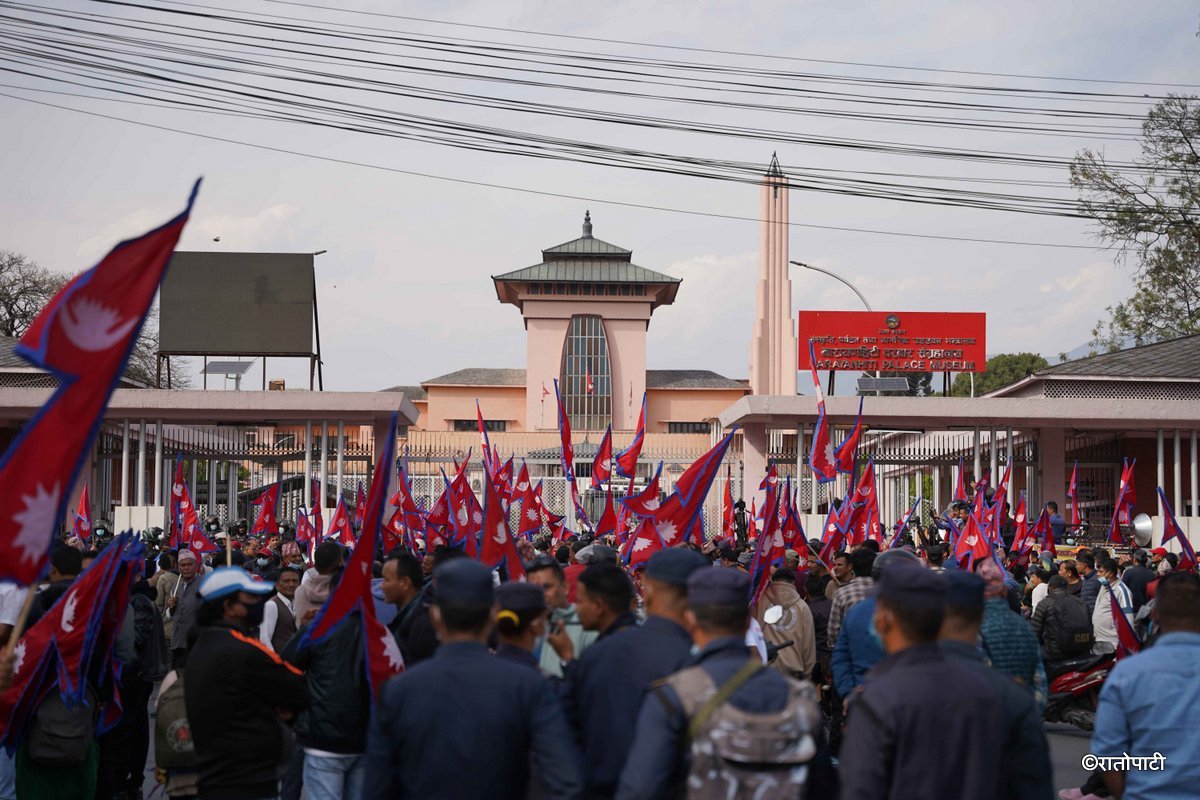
(750, 154, 797, 395)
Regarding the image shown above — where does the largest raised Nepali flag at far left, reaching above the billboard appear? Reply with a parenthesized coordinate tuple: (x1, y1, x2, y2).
(0, 181, 199, 585)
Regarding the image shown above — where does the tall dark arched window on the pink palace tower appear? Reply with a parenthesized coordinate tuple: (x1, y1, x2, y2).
(559, 315, 612, 431)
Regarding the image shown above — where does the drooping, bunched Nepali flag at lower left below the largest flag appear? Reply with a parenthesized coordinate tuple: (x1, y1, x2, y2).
(0, 533, 145, 747)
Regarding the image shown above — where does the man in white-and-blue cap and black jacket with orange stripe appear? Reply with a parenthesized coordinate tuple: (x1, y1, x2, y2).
(184, 567, 308, 800)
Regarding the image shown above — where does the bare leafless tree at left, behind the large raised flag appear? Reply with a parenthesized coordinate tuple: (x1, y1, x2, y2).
(0, 249, 192, 389)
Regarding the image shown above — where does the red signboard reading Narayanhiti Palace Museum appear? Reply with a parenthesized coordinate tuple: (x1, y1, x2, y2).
(797, 311, 988, 372)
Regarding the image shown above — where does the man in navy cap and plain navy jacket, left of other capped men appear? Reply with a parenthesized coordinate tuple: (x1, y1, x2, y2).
(365, 558, 583, 800)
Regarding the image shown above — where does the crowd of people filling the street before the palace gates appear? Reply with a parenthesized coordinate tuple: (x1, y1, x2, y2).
(0, 496, 1200, 800)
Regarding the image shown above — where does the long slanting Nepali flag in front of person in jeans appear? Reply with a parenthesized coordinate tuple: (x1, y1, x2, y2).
(299, 413, 404, 698)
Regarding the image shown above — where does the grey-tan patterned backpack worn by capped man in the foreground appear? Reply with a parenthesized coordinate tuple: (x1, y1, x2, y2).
(659, 660, 821, 800)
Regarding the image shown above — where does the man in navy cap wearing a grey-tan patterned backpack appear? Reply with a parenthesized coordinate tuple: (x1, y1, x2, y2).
(617, 567, 838, 800)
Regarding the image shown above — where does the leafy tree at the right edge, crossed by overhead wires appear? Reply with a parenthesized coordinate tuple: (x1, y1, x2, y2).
(1070, 95, 1200, 351)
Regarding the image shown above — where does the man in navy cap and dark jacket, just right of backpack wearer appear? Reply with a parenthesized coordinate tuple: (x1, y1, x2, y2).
(840, 564, 1003, 800)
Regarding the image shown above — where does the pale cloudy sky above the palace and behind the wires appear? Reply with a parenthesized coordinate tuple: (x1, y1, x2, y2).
(0, 0, 1200, 390)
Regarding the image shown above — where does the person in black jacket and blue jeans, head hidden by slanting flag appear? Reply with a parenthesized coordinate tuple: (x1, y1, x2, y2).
(283, 612, 371, 800)
